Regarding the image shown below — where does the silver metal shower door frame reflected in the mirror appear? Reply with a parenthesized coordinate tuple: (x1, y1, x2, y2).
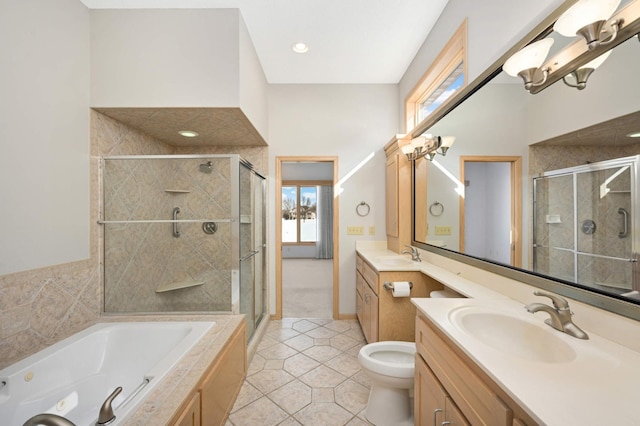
(532, 155, 640, 291)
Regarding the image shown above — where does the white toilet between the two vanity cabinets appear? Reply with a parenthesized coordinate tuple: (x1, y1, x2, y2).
(358, 341, 416, 426)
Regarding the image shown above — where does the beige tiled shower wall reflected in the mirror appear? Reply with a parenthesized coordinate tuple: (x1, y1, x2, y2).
(529, 145, 640, 289)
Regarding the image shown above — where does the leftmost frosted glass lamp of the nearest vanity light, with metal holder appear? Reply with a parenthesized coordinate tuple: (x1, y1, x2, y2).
(502, 38, 554, 91)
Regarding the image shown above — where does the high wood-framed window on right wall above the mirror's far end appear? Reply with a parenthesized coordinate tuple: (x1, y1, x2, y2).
(405, 20, 467, 133)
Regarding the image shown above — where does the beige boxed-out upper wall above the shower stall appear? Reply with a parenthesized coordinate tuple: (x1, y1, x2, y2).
(91, 9, 267, 138)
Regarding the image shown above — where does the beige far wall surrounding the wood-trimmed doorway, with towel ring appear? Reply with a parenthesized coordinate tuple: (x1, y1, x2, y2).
(269, 84, 400, 315)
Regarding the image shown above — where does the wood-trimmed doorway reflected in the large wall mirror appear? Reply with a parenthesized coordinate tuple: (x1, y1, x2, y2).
(460, 156, 522, 267)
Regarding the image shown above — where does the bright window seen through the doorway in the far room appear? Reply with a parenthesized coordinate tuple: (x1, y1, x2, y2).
(282, 183, 318, 244)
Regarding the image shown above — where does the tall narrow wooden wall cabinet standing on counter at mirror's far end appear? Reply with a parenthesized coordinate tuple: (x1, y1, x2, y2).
(384, 135, 411, 253)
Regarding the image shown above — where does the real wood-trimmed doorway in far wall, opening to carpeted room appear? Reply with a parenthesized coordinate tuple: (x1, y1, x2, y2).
(273, 156, 339, 319)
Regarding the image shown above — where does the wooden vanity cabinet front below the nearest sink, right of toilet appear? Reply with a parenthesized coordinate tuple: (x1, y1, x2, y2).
(414, 313, 536, 426)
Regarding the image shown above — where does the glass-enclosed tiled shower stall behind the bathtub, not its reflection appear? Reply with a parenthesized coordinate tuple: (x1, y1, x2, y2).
(100, 155, 266, 337)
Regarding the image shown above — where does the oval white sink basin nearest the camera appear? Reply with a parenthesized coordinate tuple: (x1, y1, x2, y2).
(449, 306, 576, 363)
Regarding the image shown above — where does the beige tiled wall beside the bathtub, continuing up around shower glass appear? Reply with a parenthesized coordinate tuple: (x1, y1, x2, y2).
(0, 111, 268, 368)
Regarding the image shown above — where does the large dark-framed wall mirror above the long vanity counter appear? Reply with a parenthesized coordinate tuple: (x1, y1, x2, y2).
(411, 0, 640, 319)
